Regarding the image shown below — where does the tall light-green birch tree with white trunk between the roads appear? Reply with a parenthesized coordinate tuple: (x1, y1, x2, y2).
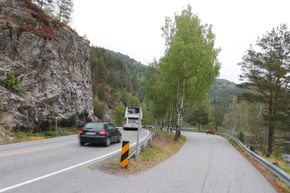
(159, 5, 220, 141)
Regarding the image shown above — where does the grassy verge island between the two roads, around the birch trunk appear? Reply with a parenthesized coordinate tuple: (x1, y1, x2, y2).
(95, 131, 186, 175)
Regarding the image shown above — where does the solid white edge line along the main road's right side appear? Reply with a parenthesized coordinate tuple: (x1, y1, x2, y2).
(0, 130, 149, 193)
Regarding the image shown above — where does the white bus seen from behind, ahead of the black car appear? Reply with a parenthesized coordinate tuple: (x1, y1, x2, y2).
(123, 107, 143, 130)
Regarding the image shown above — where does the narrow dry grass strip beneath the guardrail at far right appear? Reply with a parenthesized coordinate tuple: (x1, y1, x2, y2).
(228, 139, 290, 193)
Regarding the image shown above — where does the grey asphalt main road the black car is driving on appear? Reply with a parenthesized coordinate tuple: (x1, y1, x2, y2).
(0, 129, 148, 193)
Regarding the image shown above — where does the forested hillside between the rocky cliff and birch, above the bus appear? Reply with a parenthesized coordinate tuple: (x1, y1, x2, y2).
(90, 47, 146, 120)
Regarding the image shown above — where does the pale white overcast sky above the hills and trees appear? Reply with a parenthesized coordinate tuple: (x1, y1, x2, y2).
(72, 0, 290, 82)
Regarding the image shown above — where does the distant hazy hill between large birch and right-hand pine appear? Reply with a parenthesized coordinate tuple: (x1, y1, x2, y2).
(209, 79, 244, 112)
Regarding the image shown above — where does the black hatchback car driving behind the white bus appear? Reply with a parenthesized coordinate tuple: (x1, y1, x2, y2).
(79, 123, 122, 146)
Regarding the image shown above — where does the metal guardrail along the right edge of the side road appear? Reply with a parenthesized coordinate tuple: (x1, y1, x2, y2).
(217, 132, 290, 186)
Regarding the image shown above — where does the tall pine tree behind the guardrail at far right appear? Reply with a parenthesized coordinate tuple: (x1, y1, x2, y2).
(240, 25, 290, 156)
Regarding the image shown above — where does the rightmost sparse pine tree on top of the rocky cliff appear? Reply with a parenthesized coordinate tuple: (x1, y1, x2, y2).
(55, 0, 73, 23)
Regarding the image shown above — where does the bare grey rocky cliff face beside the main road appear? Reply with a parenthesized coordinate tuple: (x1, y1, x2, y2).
(0, 0, 93, 138)
